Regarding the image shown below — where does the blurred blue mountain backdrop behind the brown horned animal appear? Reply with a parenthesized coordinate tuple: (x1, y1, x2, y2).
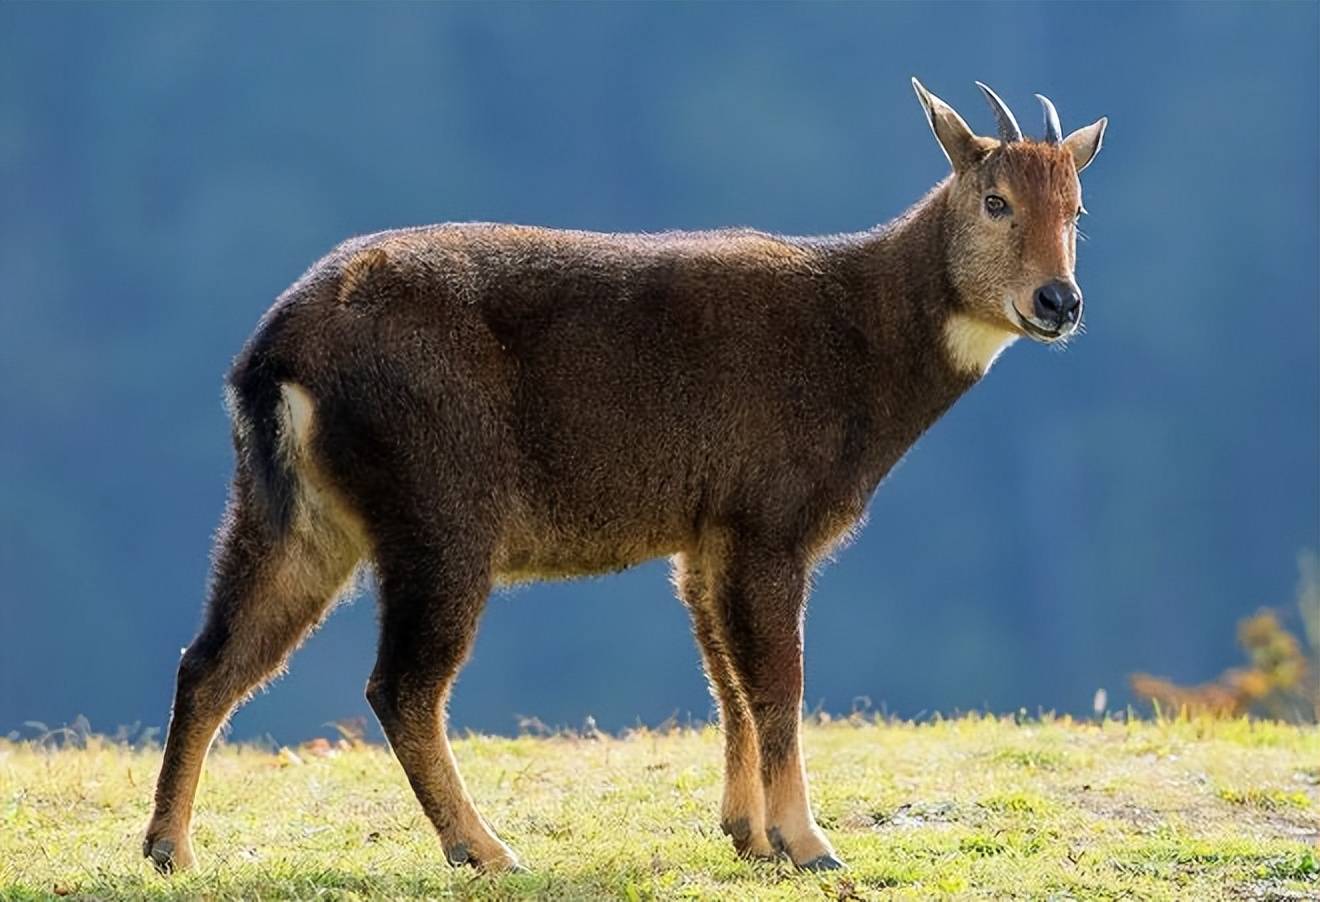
(0, 3, 1320, 741)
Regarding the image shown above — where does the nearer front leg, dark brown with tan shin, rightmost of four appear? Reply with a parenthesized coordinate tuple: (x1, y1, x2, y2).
(718, 540, 843, 870)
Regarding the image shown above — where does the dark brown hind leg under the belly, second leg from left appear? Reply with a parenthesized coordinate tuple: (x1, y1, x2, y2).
(367, 524, 519, 870)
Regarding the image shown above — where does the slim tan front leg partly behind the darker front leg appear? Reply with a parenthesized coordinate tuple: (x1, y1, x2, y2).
(675, 553, 775, 858)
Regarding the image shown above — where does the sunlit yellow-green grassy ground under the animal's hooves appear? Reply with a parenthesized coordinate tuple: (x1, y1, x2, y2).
(0, 717, 1320, 899)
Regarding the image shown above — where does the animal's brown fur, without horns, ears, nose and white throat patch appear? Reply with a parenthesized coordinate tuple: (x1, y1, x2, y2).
(145, 84, 1103, 870)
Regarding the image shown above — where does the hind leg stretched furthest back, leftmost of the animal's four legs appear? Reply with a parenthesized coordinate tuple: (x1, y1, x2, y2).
(143, 474, 358, 873)
